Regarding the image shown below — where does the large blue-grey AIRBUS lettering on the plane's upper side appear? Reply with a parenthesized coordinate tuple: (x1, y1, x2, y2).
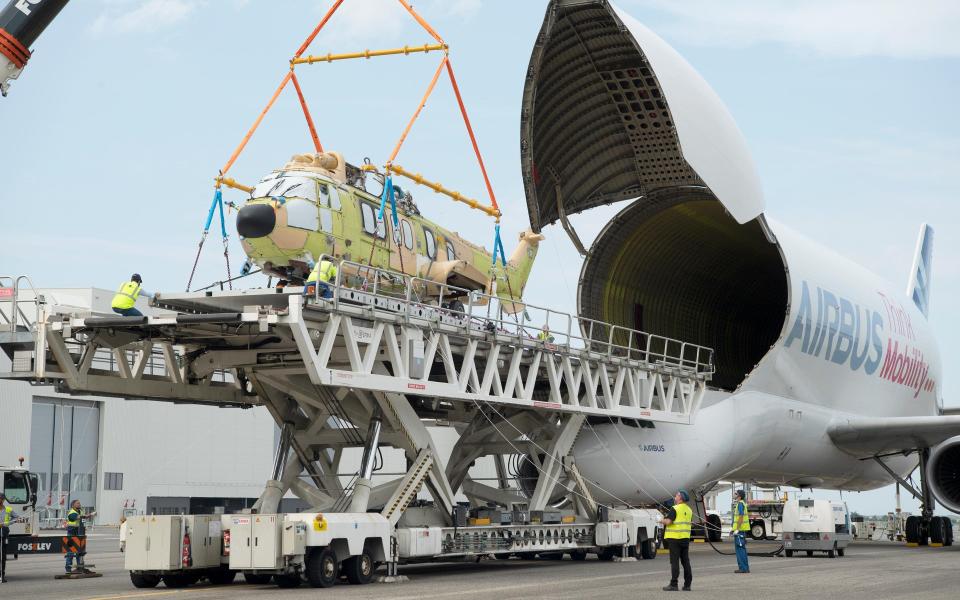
(784, 281, 883, 375)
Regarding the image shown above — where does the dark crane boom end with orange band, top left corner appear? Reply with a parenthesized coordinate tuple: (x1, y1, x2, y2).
(0, 0, 68, 96)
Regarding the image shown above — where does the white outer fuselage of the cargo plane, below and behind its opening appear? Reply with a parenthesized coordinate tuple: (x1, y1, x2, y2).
(574, 218, 941, 504)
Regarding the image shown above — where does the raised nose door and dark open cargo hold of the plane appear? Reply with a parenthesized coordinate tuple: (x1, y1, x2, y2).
(520, 0, 788, 390)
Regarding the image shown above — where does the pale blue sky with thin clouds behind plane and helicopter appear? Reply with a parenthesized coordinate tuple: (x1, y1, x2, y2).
(0, 0, 960, 513)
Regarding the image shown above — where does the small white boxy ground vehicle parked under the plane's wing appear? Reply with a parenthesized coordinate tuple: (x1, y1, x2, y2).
(783, 499, 853, 558)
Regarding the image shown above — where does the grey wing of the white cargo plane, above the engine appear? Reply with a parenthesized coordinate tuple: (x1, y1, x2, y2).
(827, 415, 960, 458)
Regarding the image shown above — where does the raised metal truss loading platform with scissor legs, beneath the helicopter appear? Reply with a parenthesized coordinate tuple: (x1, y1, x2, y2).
(0, 268, 713, 522)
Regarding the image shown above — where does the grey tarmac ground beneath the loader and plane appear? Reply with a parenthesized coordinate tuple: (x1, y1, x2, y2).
(0, 533, 960, 600)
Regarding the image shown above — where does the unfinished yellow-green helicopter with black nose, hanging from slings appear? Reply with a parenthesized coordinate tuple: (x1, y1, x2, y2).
(237, 152, 543, 312)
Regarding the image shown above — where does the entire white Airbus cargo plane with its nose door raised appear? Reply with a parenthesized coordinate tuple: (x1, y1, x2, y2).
(521, 0, 960, 543)
